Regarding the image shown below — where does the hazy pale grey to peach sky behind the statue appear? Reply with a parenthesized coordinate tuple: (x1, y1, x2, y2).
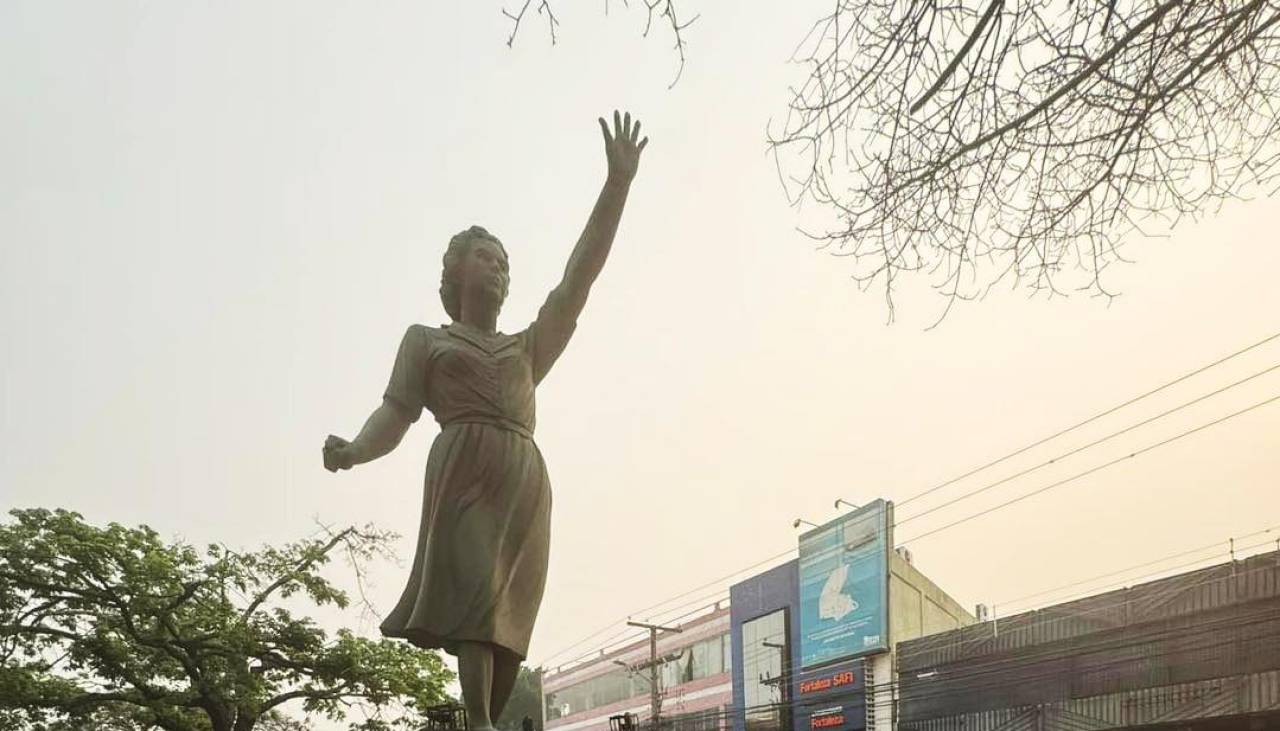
(0, 0, 1280, 722)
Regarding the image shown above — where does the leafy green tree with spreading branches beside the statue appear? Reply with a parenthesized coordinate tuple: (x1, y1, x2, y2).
(0, 510, 453, 731)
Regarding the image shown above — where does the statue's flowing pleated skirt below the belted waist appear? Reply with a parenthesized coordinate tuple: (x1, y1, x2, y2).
(381, 421, 552, 659)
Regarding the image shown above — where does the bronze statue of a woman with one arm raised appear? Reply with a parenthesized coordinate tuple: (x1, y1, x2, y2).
(324, 111, 649, 731)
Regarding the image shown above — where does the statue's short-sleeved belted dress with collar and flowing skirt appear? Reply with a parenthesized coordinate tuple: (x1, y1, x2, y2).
(381, 293, 577, 658)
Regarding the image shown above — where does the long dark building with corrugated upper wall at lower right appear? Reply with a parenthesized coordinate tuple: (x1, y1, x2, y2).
(899, 552, 1280, 731)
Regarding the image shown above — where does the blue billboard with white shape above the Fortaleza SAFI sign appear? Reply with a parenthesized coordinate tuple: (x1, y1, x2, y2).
(800, 501, 891, 667)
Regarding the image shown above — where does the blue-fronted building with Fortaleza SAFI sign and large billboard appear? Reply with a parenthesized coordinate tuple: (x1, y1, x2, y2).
(730, 501, 975, 731)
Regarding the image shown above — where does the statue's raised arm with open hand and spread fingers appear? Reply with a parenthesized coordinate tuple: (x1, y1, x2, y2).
(530, 111, 649, 380)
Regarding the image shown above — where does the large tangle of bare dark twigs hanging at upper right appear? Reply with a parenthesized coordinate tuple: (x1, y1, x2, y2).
(769, 0, 1280, 316)
